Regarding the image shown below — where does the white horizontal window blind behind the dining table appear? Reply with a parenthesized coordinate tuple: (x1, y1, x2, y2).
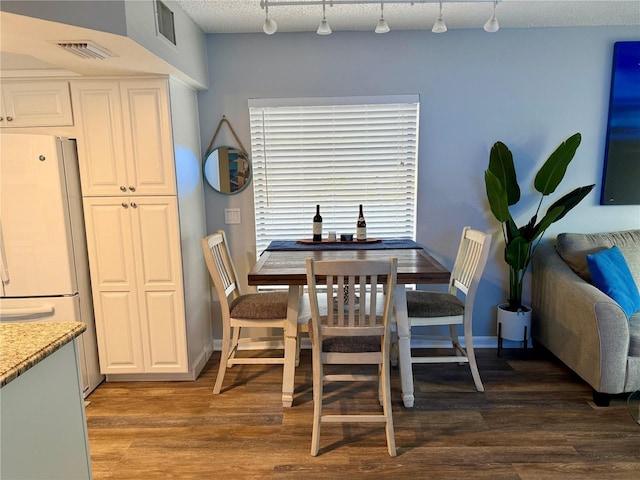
(249, 95, 419, 255)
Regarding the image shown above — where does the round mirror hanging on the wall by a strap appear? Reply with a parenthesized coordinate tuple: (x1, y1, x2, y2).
(204, 146, 251, 193)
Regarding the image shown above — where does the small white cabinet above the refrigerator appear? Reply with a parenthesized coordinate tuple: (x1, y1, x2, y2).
(0, 80, 73, 128)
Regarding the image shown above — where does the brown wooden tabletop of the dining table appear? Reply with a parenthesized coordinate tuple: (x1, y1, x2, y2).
(248, 249, 451, 285)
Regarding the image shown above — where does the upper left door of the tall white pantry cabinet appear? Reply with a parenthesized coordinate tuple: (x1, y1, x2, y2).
(71, 81, 129, 196)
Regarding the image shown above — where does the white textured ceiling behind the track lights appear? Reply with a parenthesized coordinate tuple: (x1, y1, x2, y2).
(176, 0, 640, 33)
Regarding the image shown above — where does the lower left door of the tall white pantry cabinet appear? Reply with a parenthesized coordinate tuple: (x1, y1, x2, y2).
(84, 196, 144, 374)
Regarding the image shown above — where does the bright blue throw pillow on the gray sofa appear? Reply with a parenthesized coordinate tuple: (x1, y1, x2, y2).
(587, 246, 640, 317)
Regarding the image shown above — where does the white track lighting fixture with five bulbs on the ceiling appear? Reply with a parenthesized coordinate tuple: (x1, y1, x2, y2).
(260, 0, 502, 35)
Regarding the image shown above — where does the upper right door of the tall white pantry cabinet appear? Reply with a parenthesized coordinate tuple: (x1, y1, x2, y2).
(120, 80, 176, 195)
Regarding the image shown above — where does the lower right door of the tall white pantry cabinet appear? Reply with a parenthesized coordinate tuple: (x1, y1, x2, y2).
(130, 197, 188, 373)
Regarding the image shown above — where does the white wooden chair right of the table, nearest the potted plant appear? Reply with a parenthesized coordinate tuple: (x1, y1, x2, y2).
(407, 227, 491, 392)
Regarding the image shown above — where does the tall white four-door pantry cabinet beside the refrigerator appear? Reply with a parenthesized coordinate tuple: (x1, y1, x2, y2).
(71, 78, 213, 381)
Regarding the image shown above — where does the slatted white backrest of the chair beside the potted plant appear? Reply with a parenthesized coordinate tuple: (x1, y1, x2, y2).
(449, 227, 491, 303)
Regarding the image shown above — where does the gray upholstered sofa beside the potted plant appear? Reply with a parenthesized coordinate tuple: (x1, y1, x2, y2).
(531, 230, 640, 406)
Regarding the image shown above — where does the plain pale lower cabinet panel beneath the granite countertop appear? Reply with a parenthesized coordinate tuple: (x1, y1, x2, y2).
(0, 341, 92, 480)
